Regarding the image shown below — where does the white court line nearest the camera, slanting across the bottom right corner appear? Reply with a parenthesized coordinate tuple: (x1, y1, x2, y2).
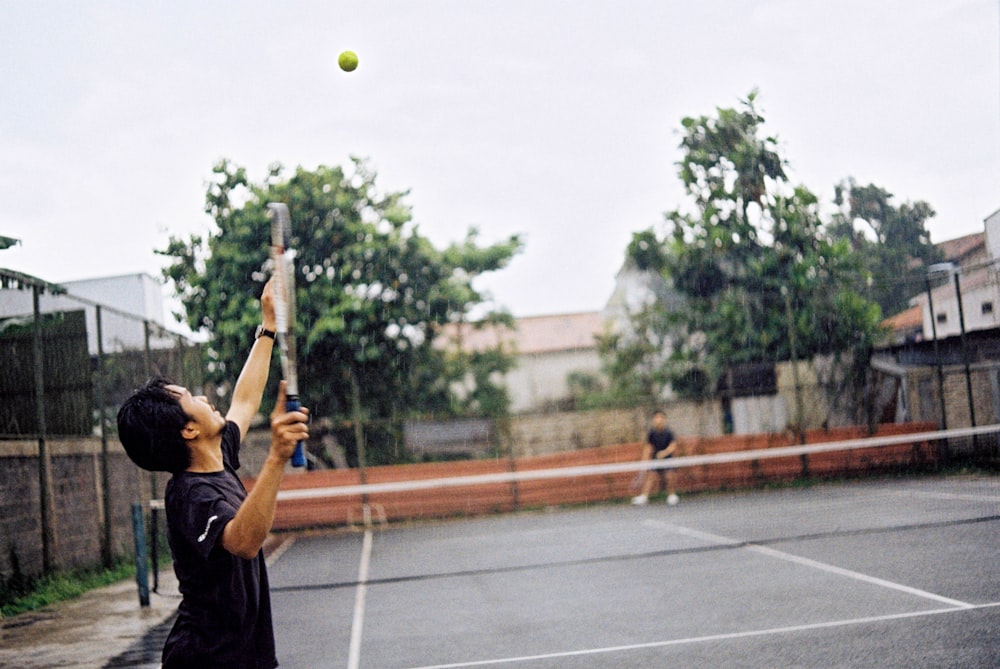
(411, 602, 1000, 669)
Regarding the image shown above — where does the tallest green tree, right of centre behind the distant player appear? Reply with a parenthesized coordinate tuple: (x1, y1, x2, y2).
(609, 92, 879, 418)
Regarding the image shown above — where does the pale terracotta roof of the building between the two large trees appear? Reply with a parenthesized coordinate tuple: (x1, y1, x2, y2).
(442, 311, 605, 355)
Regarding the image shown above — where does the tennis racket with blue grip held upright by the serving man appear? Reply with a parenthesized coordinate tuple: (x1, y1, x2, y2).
(267, 202, 306, 467)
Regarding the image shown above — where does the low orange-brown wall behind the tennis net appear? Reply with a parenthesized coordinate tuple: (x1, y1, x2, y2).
(260, 423, 937, 530)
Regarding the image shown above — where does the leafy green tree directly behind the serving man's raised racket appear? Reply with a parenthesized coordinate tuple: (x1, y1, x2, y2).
(162, 159, 522, 464)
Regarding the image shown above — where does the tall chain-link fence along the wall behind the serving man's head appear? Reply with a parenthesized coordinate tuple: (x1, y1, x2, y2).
(0, 270, 202, 586)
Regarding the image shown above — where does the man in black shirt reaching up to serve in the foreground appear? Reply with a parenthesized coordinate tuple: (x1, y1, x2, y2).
(118, 283, 309, 669)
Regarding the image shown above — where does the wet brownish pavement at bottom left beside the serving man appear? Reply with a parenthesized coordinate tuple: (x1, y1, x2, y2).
(0, 567, 180, 669)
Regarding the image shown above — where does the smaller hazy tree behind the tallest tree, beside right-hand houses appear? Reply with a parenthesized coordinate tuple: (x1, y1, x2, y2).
(830, 178, 943, 316)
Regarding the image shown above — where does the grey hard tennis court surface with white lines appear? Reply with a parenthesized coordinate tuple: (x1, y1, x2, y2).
(270, 473, 1000, 669)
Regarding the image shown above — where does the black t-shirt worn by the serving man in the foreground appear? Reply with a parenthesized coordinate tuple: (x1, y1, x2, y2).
(163, 422, 278, 669)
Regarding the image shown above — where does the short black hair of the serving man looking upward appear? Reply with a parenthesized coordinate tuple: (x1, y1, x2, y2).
(118, 376, 191, 474)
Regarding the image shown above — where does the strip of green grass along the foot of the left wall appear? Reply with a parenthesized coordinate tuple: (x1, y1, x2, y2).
(0, 560, 135, 618)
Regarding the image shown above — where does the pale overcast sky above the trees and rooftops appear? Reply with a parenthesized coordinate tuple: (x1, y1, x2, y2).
(0, 0, 1000, 316)
